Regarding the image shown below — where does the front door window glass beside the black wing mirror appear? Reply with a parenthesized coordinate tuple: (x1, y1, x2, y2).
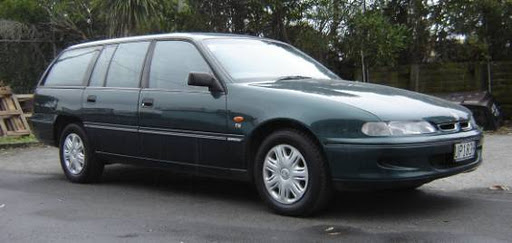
(149, 41, 211, 90)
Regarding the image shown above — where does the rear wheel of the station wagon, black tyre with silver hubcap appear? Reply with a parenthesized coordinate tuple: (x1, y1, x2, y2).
(59, 124, 104, 183)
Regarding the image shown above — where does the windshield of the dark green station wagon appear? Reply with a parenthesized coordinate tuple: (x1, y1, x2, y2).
(205, 39, 338, 82)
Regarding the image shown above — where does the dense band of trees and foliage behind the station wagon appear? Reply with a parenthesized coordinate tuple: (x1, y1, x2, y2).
(0, 0, 512, 91)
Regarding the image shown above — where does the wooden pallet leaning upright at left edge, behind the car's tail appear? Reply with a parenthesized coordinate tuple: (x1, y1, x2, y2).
(0, 86, 31, 136)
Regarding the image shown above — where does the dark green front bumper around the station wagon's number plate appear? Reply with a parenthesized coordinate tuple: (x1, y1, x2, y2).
(325, 131, 482, 189)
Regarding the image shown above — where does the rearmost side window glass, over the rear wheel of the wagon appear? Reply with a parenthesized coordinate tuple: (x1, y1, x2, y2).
(44, 47, 98, 86)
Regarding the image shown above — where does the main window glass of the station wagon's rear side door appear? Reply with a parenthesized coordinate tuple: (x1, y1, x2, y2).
(107, 42, 149, 88)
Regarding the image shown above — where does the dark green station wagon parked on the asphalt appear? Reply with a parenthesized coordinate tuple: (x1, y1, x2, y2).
(32, 34, 482, 215)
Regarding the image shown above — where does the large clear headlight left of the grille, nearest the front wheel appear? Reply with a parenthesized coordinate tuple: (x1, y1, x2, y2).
(361, 121, 436, 136)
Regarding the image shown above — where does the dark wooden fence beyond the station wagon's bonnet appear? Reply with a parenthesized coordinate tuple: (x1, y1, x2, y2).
(354, 62, 512, 118)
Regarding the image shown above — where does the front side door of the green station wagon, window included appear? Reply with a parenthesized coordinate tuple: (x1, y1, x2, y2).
(140, 40, 228, 167)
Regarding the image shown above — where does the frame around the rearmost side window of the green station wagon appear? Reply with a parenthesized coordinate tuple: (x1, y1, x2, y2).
(38, 46, 103, 88)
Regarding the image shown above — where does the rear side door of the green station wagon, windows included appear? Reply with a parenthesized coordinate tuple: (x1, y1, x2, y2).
(82, 41, 150, 156)
